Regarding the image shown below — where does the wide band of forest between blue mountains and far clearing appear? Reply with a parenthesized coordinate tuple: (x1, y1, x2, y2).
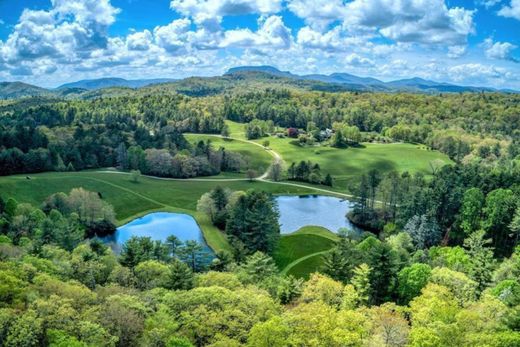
(0, 84, 520, 174)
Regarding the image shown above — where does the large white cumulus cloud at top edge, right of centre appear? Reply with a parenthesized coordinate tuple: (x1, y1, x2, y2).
(287, 0, 476, 46)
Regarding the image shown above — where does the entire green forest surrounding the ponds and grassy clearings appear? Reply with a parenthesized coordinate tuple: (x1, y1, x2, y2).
(0, 76, 520, 347)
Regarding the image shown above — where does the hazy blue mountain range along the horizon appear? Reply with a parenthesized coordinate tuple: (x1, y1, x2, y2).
(0, 66, 518, 99)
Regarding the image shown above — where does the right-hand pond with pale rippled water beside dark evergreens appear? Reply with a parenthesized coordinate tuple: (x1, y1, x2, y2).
(275, 195, 362, 234)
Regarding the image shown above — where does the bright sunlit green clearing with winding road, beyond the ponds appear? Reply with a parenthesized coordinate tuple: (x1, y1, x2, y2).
(201, 121, 452, 191)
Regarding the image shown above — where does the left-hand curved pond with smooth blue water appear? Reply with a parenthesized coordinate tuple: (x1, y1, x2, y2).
(102, 212, 213, 254)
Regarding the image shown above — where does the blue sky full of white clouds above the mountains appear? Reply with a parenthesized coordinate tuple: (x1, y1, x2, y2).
(0, 0, 520, 89)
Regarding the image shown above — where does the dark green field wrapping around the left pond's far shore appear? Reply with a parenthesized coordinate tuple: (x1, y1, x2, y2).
(0, 171, 312, 251)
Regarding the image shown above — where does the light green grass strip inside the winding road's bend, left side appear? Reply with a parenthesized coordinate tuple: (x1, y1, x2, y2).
(185, 134, 273, 178)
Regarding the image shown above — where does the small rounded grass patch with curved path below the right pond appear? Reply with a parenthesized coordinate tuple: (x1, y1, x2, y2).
(273, 226, 338, 278)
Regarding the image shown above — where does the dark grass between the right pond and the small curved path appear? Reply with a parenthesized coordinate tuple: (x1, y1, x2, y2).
(273, 226, 337, 272)
